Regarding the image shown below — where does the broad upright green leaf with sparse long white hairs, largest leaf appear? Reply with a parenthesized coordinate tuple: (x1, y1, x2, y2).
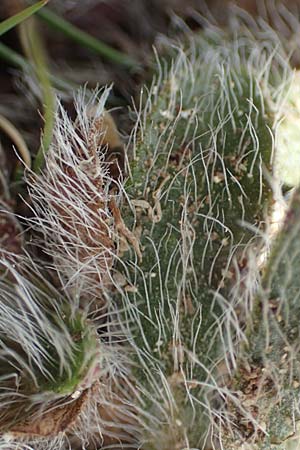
(107, 23, 291, 450)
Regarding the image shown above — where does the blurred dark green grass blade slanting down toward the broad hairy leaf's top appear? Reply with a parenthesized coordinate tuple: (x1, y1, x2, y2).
(38, 8, 138, 68)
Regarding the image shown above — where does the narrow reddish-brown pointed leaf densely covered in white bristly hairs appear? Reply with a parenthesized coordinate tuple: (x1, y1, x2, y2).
(30, 89, 119, 307)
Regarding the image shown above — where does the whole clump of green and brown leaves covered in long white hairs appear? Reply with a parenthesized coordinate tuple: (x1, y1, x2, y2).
(0, 6, 300, 450)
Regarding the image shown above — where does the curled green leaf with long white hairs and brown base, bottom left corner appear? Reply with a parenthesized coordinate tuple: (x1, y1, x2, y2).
(0, 252, 101, 442)
